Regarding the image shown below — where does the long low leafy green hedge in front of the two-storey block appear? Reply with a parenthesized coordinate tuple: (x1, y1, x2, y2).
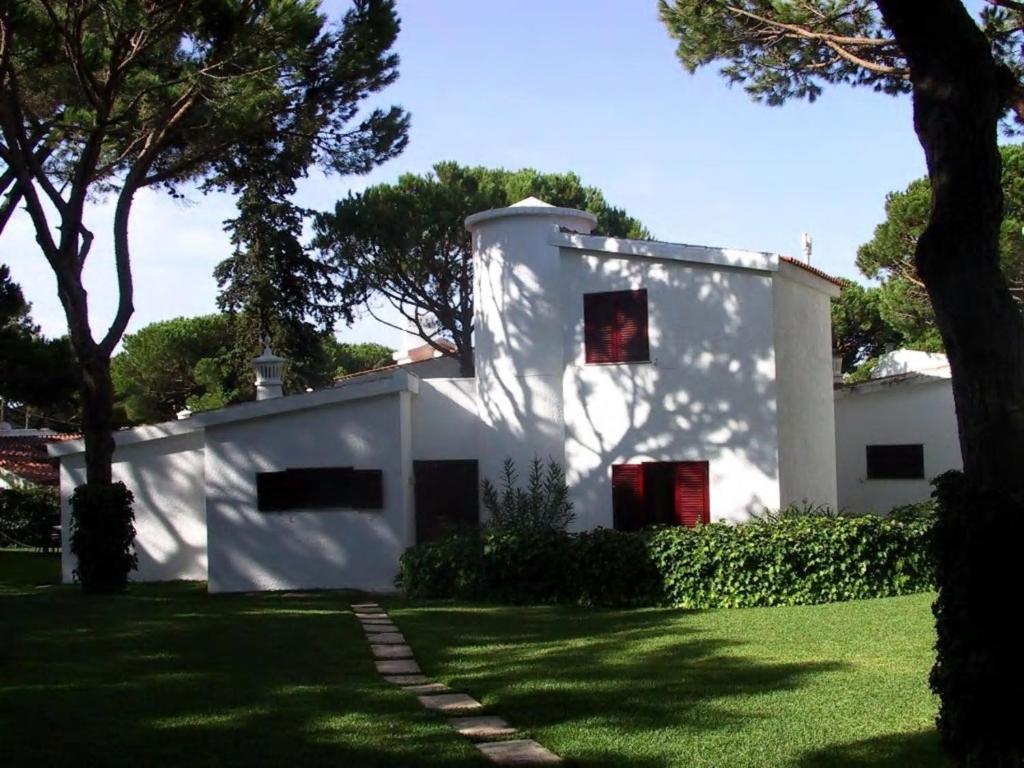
(398, 516, 934, 608)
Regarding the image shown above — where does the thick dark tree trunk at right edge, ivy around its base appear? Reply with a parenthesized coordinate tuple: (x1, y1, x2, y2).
(879, 0, 1024, 766)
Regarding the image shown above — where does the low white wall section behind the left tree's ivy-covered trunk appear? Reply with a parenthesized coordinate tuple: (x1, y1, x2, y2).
(60, 430, 207, 583)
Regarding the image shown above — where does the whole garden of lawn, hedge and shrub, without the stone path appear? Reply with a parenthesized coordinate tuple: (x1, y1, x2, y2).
(0, 465, 946, 768)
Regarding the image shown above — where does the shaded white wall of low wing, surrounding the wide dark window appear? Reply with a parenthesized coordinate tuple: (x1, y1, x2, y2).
(206, 391, 415, 592)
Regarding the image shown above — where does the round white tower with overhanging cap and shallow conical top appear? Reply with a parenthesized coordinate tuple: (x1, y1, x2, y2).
(466, 198, 597, 480)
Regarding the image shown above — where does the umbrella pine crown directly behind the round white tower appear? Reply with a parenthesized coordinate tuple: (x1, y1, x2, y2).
(315, 162, 649, 376)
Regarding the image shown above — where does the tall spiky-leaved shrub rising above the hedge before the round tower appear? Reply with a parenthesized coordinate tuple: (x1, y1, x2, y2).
(483, 458, 575, 530)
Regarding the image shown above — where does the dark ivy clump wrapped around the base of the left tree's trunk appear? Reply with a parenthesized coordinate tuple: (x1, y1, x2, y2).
(71, 482, 138, 593)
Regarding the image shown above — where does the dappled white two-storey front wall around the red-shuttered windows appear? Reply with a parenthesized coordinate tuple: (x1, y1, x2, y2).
(561, 248, 778, 528)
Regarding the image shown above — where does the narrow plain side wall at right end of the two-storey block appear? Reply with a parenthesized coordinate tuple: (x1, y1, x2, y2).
(774, 262, 839, 509)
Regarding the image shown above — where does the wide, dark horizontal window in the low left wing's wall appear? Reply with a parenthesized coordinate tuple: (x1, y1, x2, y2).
(256, 467, 384, 512)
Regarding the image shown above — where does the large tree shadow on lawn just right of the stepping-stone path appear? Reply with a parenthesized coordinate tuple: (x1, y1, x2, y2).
(395, 607, 851, 767)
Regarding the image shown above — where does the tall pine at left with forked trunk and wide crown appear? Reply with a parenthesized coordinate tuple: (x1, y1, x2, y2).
(0, 0, 408, 484)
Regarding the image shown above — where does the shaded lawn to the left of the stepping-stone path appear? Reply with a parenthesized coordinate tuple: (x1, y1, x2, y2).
(0, 553, 486, 768)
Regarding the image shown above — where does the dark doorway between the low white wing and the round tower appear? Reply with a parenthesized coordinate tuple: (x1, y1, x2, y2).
(413, 459, 480, 544)
